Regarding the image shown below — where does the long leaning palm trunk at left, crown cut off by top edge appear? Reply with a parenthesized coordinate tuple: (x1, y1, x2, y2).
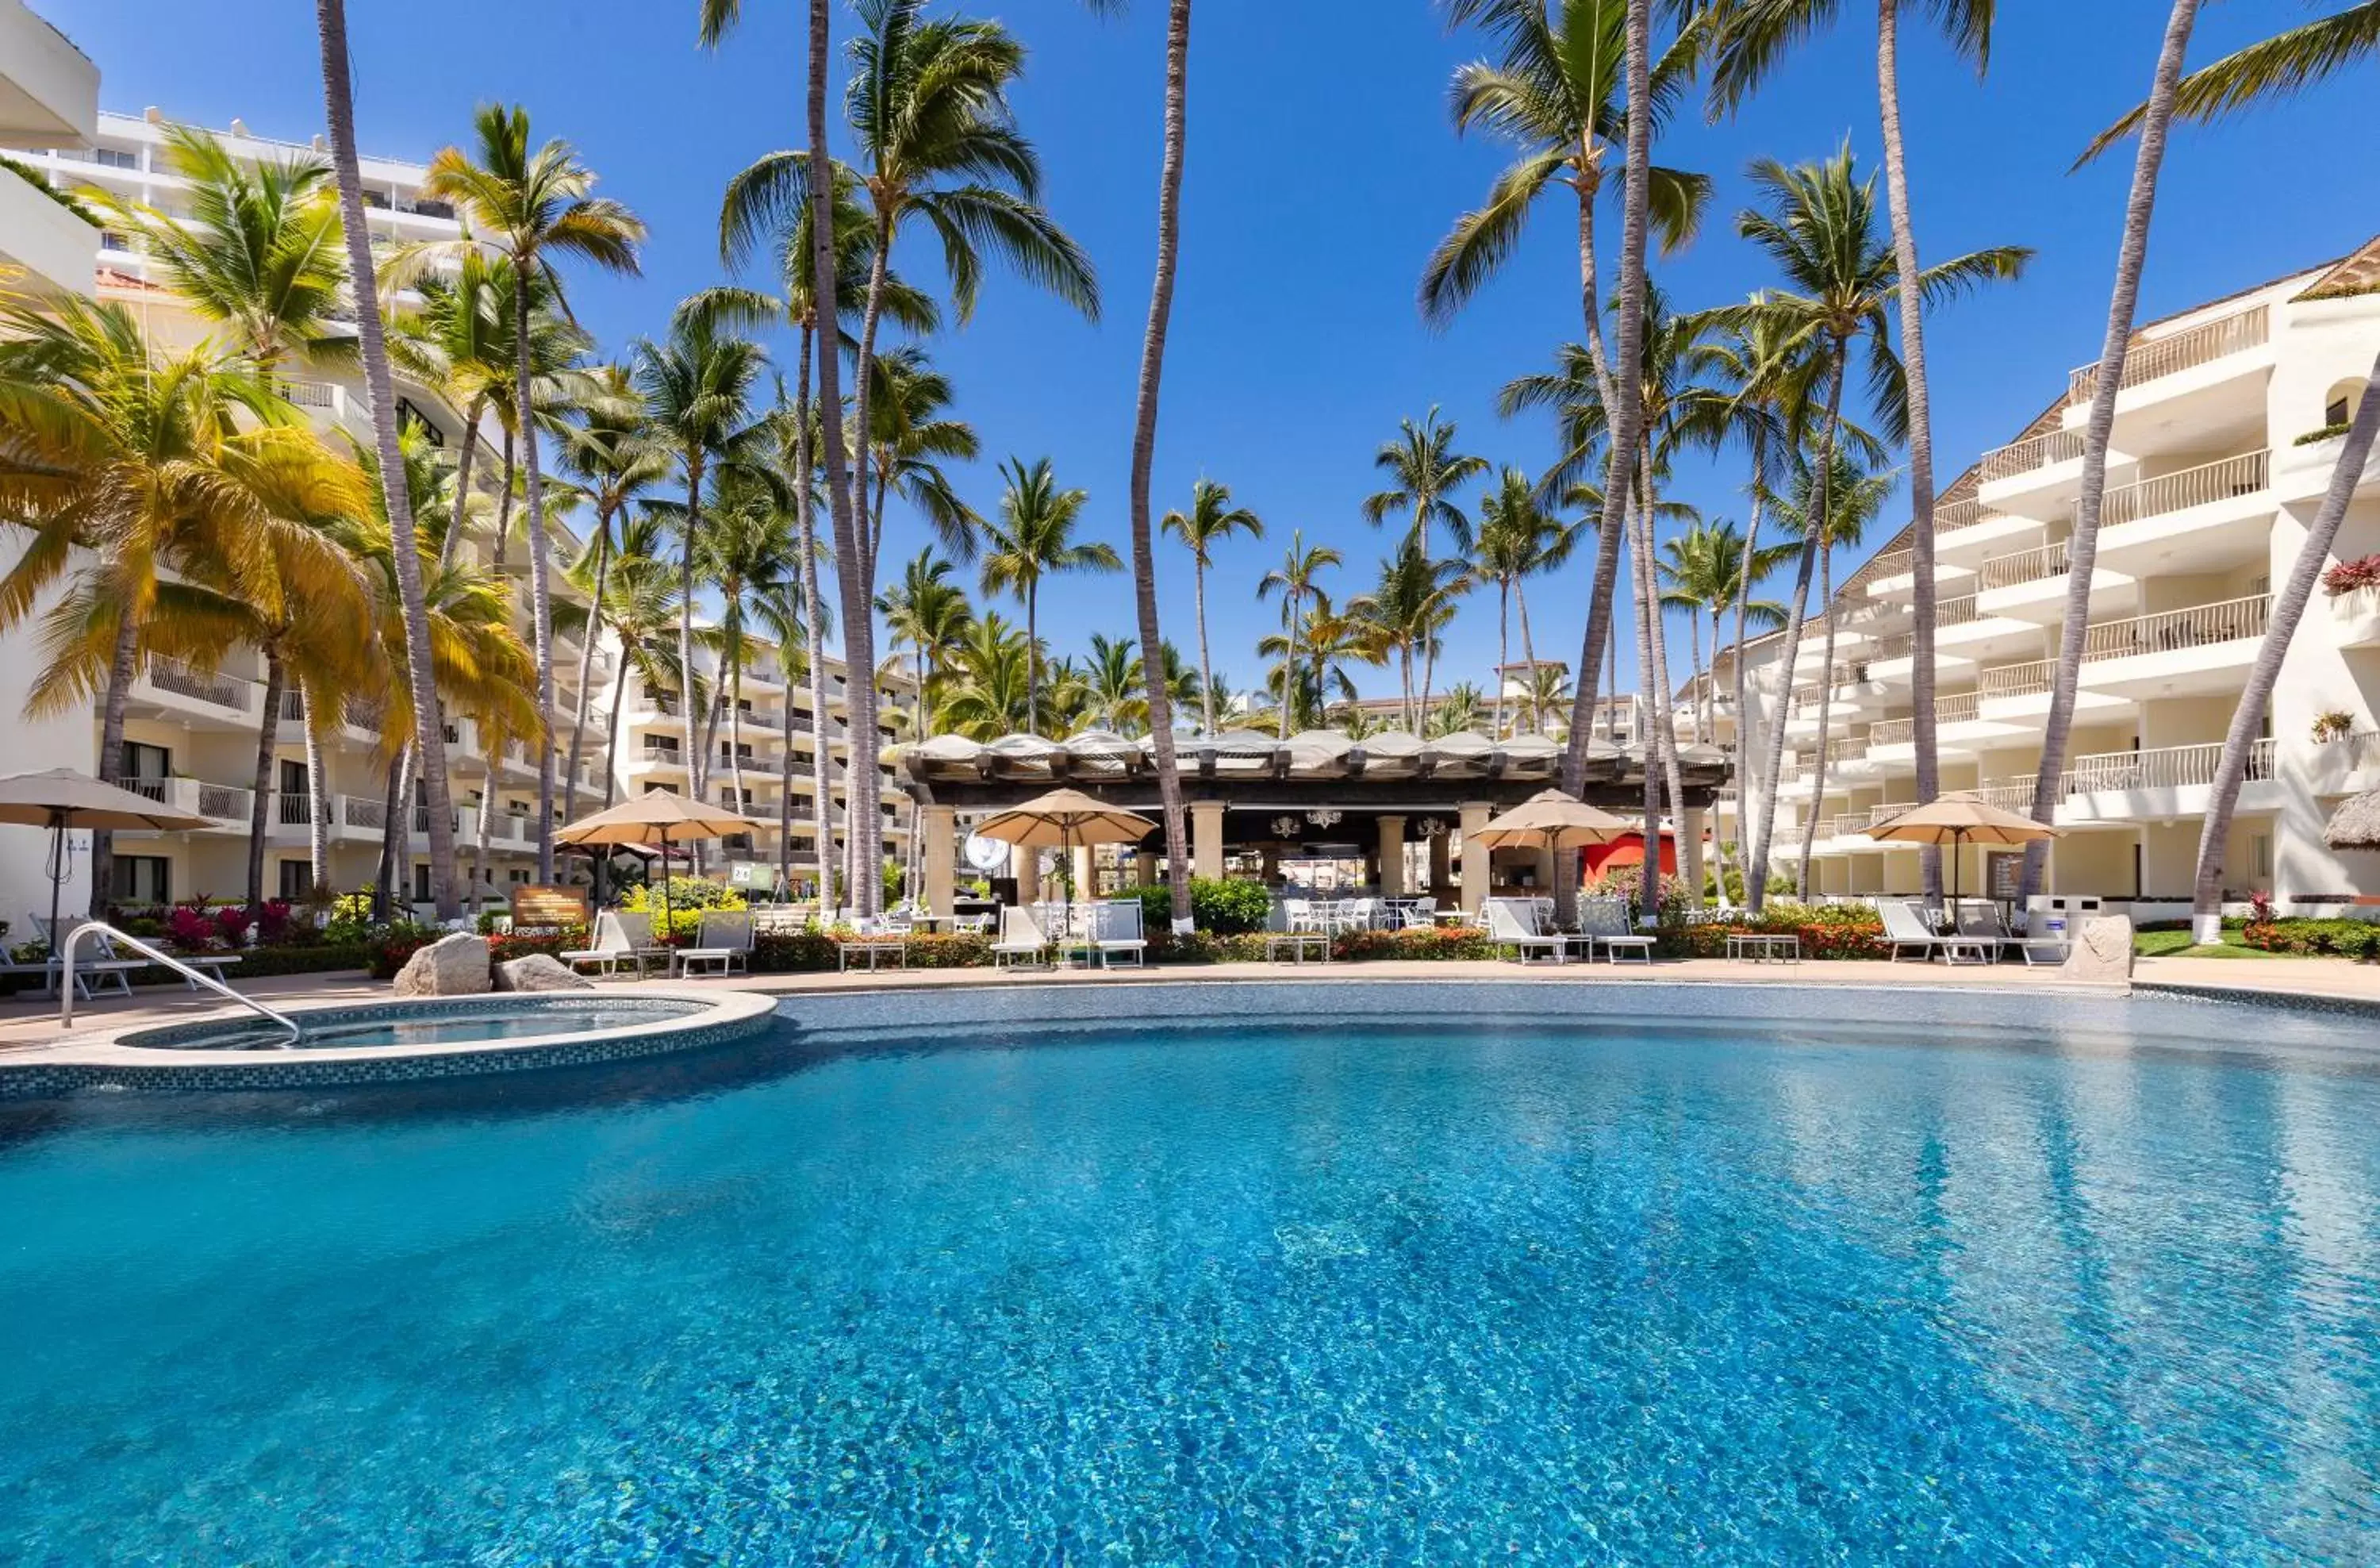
(314, 0, 457, 920)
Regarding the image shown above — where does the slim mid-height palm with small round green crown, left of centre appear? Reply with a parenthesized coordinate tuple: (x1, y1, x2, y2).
(633, 309, 766, 813)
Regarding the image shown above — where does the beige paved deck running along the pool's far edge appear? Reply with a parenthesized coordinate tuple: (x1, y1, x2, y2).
(0, 959, 2380, 1054)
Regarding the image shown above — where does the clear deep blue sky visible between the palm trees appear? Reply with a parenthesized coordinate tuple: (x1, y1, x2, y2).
(36, 0, 2380, 693)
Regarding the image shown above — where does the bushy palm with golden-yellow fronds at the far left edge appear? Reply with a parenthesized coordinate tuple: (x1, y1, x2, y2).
(0, 298, 352, 911)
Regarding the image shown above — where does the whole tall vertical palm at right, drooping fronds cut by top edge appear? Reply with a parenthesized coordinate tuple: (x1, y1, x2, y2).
(1709, 0, 1997, 899)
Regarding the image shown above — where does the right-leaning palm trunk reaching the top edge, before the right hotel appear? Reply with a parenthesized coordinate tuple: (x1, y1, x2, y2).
(2018, 0, 2209, 906)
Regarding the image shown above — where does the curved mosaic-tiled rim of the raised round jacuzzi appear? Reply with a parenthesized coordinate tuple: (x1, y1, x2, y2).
(0, 992, 776, 1099)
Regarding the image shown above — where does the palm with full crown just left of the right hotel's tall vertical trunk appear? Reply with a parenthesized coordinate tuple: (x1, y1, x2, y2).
(1709, 145, 2033, 911)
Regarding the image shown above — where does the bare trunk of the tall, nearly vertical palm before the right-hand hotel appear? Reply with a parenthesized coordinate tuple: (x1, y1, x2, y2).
(1885, 0, 1942, 904)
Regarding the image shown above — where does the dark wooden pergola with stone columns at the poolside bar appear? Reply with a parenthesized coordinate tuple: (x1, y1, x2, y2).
(892, 731, 1728, 909)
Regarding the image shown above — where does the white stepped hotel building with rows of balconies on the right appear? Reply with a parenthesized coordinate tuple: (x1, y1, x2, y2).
(1716, 240, 2380, 918)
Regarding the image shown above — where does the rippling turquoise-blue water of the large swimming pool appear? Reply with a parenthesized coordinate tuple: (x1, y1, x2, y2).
(0, 999, 2380, 1566)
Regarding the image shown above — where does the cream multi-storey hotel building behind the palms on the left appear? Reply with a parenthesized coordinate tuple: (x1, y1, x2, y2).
(0, 0, 907, 940)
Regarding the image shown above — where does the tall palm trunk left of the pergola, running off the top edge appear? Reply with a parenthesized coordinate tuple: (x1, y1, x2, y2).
(807, 0, 883, 913)
